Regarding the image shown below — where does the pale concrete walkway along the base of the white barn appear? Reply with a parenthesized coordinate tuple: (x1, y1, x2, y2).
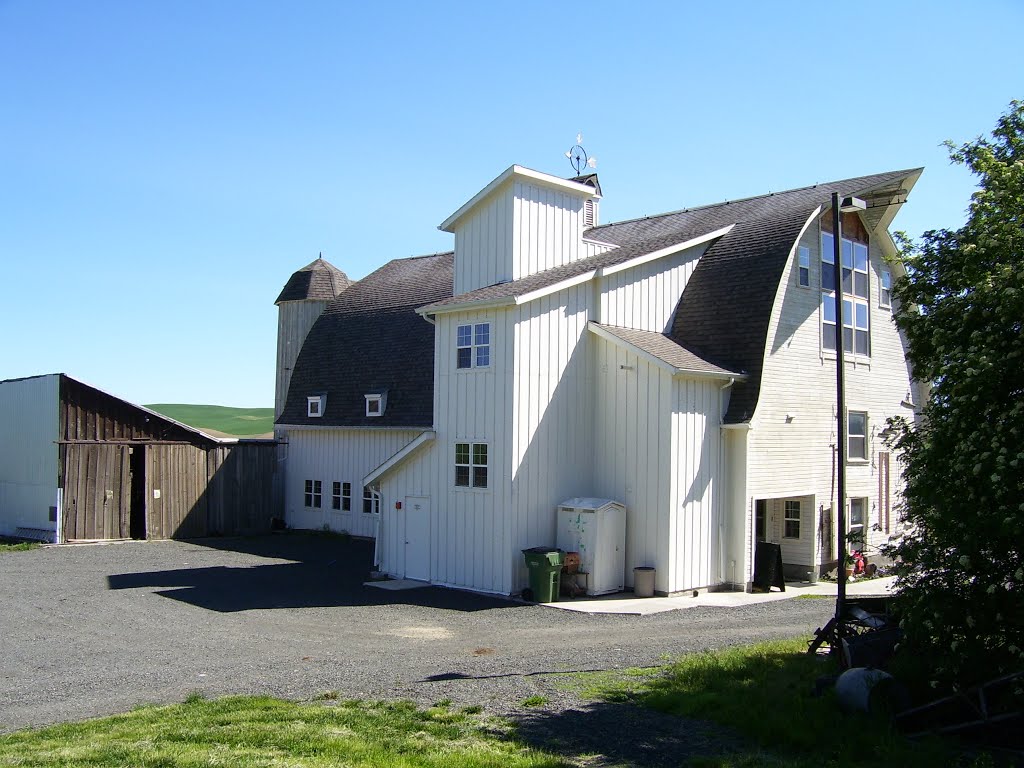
(544, 577, 895, 616)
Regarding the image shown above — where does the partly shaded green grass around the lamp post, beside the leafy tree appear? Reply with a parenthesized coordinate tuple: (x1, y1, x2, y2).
(569, 639, 970, 768)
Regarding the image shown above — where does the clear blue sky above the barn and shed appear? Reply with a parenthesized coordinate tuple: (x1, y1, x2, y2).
(0, 0, 1024, 407)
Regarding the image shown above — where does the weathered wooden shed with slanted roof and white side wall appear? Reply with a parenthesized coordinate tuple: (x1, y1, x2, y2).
(0, 374, 275, 543)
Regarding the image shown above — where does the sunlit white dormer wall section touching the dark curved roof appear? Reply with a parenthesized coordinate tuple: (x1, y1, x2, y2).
(598, 244, 708, 333)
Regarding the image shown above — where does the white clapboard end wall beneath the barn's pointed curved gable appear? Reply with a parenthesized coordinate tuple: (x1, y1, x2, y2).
(748, 212, 913, 567)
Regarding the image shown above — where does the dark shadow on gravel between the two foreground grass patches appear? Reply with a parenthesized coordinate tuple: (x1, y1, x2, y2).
(512, 702, 741, 768)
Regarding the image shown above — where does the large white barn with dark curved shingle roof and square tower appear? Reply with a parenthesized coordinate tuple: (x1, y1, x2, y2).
(278, 166, 921, 594)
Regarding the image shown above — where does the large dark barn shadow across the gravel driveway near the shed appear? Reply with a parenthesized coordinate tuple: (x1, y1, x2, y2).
(106, 534, 519, 613)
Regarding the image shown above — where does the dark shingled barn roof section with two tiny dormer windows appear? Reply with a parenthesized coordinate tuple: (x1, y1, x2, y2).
(278, 253, 455, 428)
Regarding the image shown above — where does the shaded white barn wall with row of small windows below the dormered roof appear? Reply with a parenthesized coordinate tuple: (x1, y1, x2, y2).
(285, 427, 423, 537)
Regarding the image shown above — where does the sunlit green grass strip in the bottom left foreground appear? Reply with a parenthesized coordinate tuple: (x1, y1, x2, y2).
(0, 695, 566, 768)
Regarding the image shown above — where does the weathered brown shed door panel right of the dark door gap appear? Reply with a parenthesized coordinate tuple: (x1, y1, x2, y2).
(145, 444, 209, 539)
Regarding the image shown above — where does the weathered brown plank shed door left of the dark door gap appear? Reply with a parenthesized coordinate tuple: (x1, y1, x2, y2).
(61, 443, 132, 542)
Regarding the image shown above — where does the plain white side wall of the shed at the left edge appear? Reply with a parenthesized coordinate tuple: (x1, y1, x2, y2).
(0, 374, 60, 536)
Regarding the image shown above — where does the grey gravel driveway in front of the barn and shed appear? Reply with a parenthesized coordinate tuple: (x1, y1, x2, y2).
(0, 534, 831, 766)
